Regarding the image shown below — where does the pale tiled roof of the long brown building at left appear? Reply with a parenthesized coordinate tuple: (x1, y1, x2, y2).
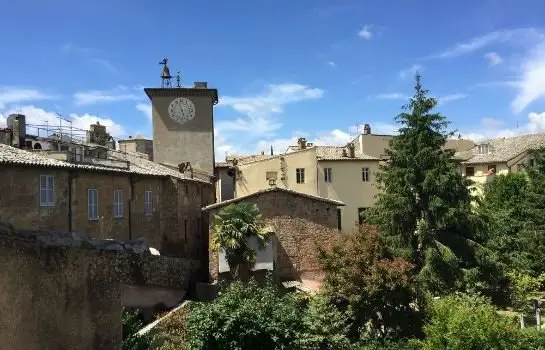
(0, 144, 210, 182)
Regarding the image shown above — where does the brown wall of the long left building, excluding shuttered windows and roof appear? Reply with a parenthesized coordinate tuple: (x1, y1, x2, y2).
(0, 165, 215, 260)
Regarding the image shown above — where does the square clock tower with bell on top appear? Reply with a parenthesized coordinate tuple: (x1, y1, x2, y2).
(144, 81, 218, 176)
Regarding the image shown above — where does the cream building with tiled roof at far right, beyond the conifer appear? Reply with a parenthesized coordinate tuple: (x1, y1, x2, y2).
(456, 134, 545, 193)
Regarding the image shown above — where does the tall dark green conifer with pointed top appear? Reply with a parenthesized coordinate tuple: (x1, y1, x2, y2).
(370, 74, 484, 292)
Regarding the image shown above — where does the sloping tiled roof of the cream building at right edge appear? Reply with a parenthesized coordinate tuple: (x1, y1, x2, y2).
(455, 134, 545, 164)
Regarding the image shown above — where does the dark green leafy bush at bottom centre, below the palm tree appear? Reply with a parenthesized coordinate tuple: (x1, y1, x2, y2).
(188, 280, 304, 350)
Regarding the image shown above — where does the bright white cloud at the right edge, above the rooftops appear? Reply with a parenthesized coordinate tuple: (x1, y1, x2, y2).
(511, 40, 545, 113)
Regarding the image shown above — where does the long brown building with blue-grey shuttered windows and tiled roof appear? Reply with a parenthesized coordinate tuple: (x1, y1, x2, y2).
(0, 144, 215, 259)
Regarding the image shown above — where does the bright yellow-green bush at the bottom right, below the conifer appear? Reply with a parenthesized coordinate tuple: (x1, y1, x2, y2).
(423, 294, 523, 350)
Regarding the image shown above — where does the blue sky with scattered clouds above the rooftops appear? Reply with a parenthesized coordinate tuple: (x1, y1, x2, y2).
(0, 0, 545, 159)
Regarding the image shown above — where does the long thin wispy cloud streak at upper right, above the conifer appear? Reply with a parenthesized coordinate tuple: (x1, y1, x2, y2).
(428, 28, 543, 58)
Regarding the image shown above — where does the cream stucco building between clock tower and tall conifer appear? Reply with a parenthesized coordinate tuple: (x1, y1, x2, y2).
(227, 124, 474, 232)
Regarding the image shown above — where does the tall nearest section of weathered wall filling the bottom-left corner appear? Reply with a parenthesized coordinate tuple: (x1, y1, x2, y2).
(0, 227, 122, 350)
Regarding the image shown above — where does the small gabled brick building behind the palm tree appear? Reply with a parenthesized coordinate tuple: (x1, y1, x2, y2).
(203, 187, 344, 282)
